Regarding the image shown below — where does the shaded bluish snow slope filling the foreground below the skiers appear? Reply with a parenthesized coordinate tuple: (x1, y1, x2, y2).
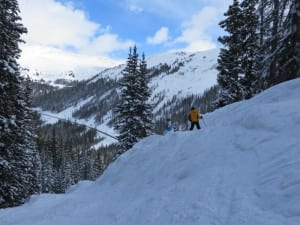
(0, 79, 300, 225)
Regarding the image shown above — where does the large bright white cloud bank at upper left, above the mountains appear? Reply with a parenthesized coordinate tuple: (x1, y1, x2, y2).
(19, 0, 133, 77)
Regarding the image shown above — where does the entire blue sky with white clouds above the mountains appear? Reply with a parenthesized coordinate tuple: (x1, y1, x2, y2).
(19, 0, 231, 76)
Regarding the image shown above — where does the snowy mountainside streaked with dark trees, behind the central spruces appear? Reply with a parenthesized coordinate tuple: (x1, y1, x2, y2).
(35, 49, 219, 142)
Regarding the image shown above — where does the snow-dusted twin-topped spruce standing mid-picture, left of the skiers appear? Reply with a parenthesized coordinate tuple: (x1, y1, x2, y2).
(115, 46, 152, 153)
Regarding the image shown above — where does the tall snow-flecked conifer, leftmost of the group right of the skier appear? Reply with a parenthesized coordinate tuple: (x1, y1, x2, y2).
(217, 0, 243, 107)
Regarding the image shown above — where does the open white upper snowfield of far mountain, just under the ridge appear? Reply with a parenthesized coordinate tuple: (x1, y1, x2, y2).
(91, 49, 219, 101)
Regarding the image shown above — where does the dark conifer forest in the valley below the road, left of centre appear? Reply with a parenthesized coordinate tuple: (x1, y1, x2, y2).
(37, 121, 118, 193)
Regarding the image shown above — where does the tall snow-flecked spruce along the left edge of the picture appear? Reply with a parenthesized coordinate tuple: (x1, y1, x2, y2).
(0, 0, 36, 207)
